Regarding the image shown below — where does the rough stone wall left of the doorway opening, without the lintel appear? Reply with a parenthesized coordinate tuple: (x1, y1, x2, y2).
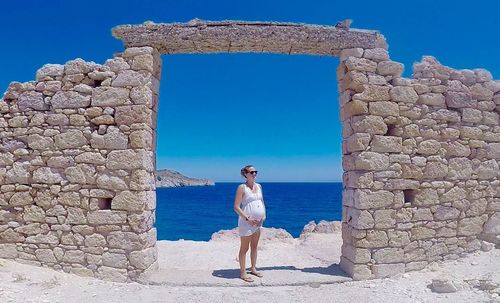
(0, 47, 161, 281)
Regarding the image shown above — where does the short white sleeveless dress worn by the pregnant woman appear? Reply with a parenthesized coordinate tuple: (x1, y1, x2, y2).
(238, 183, 266, 237)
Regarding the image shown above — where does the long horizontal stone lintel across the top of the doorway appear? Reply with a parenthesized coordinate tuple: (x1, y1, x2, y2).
(112, 19, 387, 55)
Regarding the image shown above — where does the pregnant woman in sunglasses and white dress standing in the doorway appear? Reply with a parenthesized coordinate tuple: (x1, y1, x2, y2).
(234, 165, 266, 282)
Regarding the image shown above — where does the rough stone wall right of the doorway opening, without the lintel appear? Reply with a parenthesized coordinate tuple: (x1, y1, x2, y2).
(338, 48, 500, 279)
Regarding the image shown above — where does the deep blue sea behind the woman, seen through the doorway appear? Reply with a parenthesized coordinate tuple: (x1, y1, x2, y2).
(156, 182, 342, 241)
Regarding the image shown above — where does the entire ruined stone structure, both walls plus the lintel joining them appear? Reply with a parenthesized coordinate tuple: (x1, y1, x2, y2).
(0, 20, 500, 281)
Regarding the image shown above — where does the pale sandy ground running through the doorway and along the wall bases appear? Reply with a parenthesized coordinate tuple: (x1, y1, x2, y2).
(0, 229, 500, 303)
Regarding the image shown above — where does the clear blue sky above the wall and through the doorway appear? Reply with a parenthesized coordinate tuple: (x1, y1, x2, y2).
(0, 0, 500, 181)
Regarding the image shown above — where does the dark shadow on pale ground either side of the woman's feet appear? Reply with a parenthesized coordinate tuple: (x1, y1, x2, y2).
(212, 263, 349, 279)
